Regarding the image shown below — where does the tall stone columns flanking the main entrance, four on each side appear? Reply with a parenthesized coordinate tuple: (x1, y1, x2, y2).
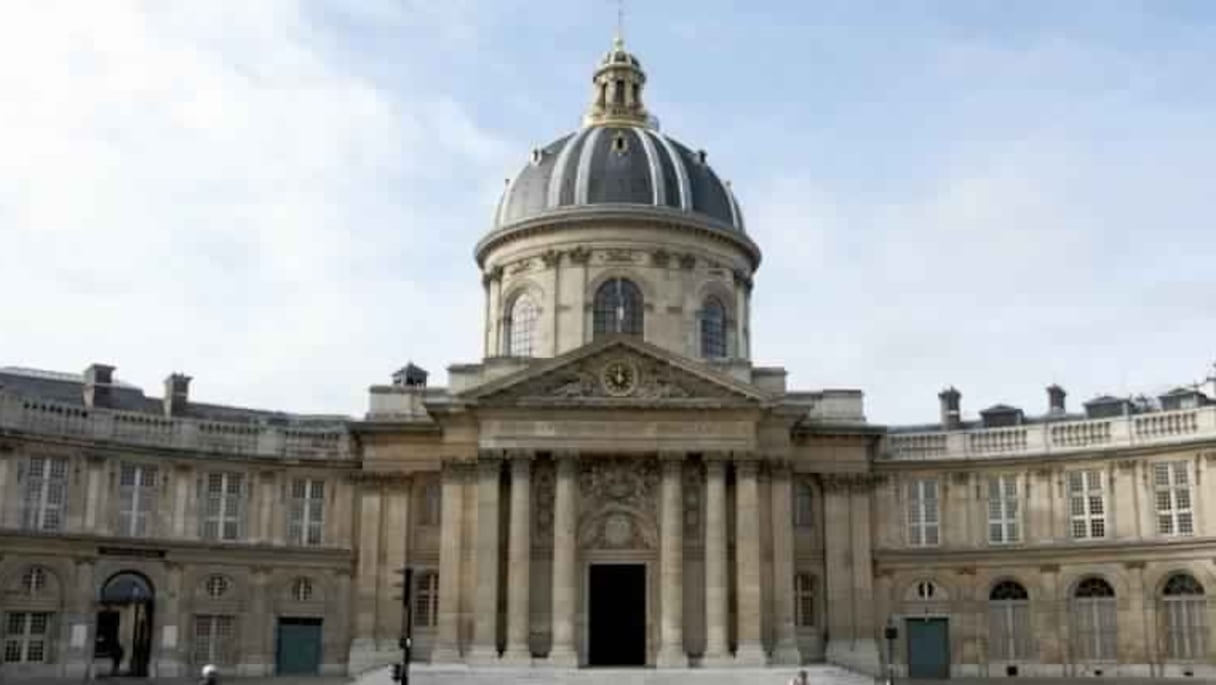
(432, 450, 799, 668)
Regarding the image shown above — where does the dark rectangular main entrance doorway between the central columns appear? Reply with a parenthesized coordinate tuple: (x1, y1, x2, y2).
(587, 563, 646, 666)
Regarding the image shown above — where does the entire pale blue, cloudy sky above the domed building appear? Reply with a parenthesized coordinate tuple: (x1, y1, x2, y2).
(0, 0, 1216, 423)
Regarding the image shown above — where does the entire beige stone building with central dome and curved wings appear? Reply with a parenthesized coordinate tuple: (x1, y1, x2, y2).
(0, 33, 1216, 676)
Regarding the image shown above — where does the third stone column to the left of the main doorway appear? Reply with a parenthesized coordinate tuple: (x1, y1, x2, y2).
(469, 451, 502, 664)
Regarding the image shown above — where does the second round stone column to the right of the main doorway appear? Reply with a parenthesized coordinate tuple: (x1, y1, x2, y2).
(702, 455, 731, 666)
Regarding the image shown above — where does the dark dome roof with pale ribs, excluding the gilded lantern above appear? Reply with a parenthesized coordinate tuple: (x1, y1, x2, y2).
(494, 125, 744, 232)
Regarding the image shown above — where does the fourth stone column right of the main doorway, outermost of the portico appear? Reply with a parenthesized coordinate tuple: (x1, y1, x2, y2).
(772, 464, 803, 666)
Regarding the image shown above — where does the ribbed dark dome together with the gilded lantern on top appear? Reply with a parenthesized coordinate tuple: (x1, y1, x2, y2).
(491, 35, 744, 234)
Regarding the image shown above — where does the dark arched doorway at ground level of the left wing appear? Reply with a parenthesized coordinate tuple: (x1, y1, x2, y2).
(94, 571, 156, 676)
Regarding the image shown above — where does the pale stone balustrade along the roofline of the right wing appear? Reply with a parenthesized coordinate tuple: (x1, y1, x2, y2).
(883, 406, 1216, 461)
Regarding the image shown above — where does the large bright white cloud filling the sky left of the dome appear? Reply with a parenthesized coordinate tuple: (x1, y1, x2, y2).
(0, 0, 508, 411)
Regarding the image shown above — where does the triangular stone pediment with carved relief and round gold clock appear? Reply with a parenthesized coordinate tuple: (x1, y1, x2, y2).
(461, 336, 772, 406)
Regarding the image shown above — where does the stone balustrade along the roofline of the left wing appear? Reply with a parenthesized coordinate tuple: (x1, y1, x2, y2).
(0, 393, 351, 459)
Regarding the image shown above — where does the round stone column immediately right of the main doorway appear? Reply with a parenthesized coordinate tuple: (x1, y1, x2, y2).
(657, 453, 688, 668)
